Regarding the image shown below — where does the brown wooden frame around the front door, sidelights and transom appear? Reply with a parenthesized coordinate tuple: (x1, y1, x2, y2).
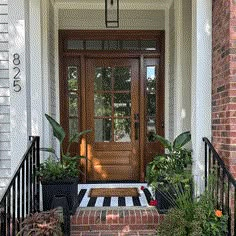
(59, 30, 165, 182)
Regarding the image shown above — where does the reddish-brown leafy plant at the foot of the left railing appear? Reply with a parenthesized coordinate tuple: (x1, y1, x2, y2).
(17, 209, 63, 236)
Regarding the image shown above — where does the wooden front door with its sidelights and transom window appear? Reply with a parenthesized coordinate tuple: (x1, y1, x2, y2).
(59, 30, 165, 182)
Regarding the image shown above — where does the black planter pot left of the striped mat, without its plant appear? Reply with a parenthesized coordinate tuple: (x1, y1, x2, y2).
(41, 179, 78, 214)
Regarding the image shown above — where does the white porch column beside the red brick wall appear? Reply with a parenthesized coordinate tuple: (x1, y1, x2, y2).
(191, 0, 212, 193)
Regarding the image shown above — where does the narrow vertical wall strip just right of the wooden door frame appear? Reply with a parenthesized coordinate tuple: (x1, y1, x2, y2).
(167, 1, 175, 140)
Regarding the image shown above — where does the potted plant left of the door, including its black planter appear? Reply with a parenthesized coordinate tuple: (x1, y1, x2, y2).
(38, 114, 90, 213)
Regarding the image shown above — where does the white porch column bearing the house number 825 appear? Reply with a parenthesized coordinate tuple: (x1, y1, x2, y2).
(8, 0, 31, 173)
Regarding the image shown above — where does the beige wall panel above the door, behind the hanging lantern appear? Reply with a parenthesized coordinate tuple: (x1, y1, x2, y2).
(59, 9, 165, 30)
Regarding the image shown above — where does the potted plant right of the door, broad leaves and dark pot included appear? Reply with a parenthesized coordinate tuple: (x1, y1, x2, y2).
(146, 131, 192, 213)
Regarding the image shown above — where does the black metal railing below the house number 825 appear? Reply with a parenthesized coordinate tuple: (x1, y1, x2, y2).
(0, 136, 40, 236)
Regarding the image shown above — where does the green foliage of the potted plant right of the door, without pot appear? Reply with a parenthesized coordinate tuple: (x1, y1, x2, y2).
(146, 131, 192, 192)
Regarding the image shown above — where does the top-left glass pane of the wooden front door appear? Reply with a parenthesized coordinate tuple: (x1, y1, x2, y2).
(94, 67, 112, 91)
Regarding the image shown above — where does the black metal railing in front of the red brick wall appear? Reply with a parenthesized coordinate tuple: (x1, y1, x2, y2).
(203, 138, 236, 235)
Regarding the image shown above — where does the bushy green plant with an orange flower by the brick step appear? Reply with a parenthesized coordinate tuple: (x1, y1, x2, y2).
(157, 185, 228, 236)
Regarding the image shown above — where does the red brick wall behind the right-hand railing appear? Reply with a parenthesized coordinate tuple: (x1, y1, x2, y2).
(212, 0, 236, 173)
